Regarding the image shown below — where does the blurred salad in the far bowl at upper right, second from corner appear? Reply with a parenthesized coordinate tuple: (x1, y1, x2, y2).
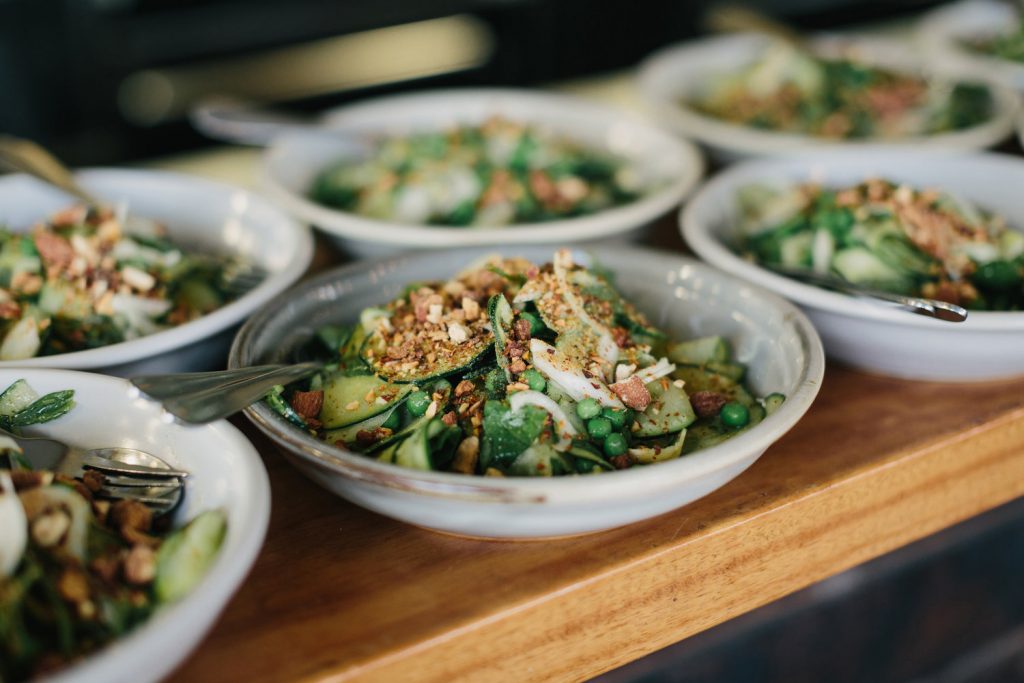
(683, 43, 994, 138)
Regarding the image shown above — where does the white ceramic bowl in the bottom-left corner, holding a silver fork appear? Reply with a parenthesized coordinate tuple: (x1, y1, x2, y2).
(0, 368, 270, 683)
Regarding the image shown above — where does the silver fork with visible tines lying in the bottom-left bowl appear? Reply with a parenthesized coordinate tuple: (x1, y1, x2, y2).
(0, 430, 188, 513)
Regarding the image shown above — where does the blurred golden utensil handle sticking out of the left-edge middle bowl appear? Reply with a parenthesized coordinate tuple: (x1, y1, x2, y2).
(0, 135, 163, 236)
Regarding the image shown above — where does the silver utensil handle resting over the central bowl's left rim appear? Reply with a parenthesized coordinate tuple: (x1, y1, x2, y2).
(131, 362, 324, 424)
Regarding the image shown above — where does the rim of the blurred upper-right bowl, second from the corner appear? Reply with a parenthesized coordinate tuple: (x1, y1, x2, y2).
(637, 33, 1020, 156)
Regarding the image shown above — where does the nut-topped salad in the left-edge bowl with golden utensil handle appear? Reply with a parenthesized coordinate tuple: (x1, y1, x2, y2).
(0, 206, 260, 360)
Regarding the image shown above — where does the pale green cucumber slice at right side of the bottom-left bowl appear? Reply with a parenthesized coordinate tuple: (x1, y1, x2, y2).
(154, 510, 227, 602)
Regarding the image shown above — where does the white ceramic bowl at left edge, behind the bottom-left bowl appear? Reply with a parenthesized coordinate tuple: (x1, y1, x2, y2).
(0, 169, 312, 376)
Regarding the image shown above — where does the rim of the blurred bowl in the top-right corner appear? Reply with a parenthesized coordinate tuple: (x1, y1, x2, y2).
(915, 0, 1024, 82)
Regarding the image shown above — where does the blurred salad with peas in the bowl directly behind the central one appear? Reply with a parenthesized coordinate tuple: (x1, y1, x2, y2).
(309, 117, 643, 226)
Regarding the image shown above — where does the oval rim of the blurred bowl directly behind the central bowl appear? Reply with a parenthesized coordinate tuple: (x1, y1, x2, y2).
(260, 88, 706, 248)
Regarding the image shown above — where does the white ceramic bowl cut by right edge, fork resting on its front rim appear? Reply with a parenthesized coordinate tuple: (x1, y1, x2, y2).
(680, 150, 1024, 381)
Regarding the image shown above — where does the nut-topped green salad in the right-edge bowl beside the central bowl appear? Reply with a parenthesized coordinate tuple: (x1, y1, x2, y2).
(738, 178, 1024, 310)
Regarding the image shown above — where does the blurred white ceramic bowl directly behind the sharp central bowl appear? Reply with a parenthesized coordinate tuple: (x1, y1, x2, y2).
(262, 89, 703, 256)
